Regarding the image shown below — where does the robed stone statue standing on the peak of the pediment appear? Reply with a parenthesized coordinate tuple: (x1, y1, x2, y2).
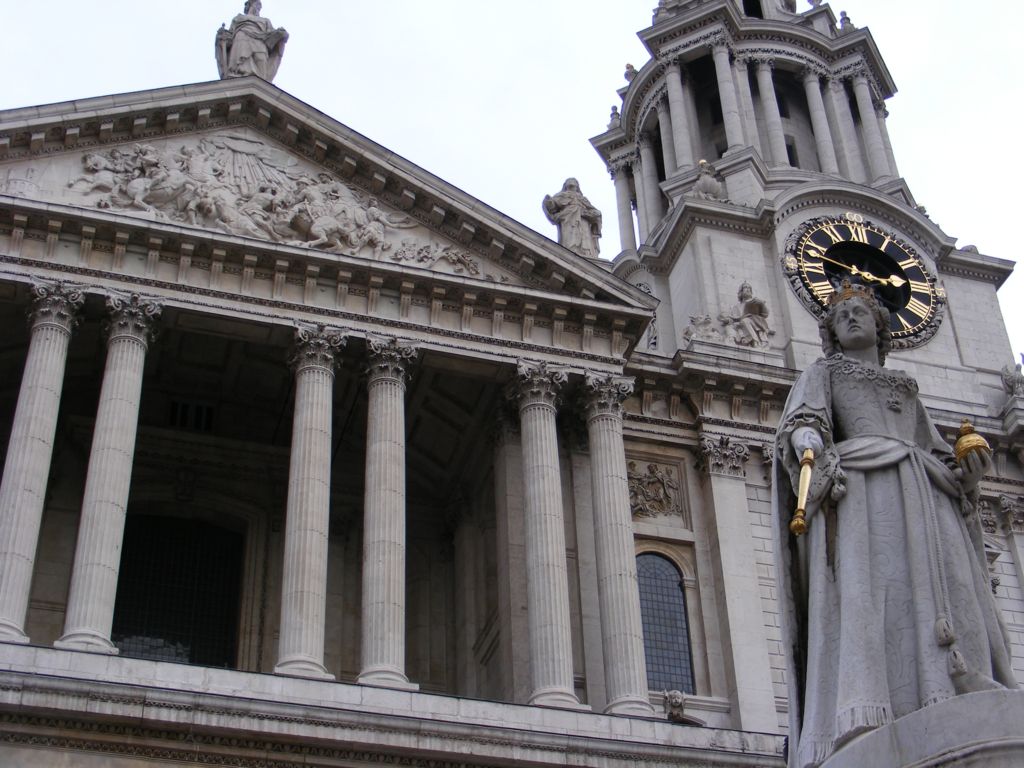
(215, 0, 288, 82)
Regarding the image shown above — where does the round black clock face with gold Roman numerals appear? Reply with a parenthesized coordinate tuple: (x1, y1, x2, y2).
(783, 212, 944, 341)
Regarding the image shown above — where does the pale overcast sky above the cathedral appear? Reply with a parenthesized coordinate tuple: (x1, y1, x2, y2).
(0, 0, 1024, 361)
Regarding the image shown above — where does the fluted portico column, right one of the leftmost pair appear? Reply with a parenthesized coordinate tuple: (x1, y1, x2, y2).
(54, 294, 162, 653)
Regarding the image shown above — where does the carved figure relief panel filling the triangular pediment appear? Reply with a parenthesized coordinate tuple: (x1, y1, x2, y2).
(0, 127, 522, 285)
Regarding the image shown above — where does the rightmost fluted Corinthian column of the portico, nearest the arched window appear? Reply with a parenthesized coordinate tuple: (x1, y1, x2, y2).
(586, 375, 654, 717)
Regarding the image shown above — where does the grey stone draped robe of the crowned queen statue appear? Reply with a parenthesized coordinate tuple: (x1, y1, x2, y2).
(773, 354, 1016, 768)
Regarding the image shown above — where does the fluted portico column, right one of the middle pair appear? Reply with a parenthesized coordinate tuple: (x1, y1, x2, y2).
(359, 339, 417, 688)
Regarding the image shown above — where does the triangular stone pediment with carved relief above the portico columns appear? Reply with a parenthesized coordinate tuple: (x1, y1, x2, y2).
(0, 78, 651, 310)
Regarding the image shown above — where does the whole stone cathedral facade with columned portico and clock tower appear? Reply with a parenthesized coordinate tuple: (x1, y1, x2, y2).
(0, 0, 1024, 768)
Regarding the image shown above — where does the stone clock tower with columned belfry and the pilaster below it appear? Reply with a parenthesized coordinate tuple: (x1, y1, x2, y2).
(591, 0, 1024, 741)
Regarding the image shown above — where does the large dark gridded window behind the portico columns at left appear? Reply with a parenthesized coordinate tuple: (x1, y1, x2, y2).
(112, 515, 243, 667)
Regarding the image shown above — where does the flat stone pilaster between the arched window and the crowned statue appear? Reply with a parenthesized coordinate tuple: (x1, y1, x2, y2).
(700, 435, 778, 731)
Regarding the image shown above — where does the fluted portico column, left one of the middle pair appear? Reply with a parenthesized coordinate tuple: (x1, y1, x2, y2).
(273, 326, 345, 679)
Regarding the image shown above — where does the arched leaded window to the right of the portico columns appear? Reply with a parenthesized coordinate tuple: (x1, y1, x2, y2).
(637, 553, 694, 693)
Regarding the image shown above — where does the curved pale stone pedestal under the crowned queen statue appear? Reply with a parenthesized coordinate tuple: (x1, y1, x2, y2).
(821, 690, 1024, 768)
